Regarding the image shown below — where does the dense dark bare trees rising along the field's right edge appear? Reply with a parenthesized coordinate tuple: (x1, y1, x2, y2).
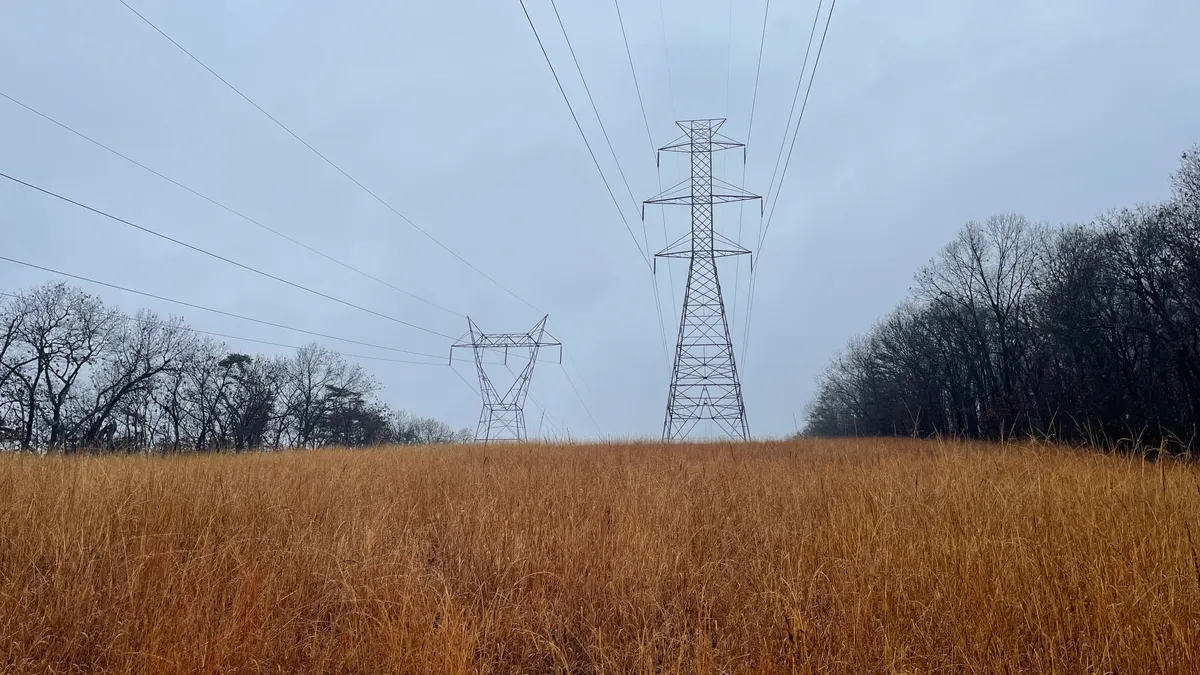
(804, 145, 1200, 450)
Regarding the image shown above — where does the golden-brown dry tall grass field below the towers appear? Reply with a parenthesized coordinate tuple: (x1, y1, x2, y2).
(0, 440, 1200, 674)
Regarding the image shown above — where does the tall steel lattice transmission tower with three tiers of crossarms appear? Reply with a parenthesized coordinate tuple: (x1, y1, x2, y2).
(642, 119, 762, 441)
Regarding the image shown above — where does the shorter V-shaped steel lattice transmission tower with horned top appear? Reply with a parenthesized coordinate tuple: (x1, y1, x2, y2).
(450, 315, 563, 443)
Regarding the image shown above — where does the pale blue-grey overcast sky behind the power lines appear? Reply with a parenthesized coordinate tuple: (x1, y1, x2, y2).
(0, 0, 1200, 437)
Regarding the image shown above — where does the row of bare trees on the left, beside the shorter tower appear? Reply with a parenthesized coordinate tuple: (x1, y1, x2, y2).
(0, 282, 472, 453)
